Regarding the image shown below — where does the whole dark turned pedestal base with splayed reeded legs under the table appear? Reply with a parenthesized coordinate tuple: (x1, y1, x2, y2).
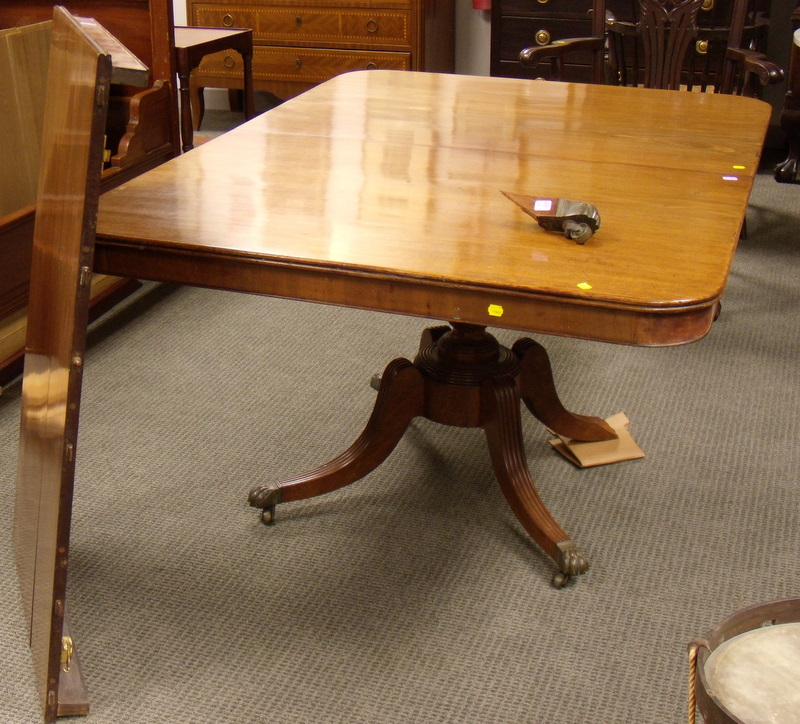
(249, 322, 616, 588)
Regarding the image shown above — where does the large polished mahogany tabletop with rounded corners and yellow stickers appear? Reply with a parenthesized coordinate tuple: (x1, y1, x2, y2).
(95, 71, 770, 345)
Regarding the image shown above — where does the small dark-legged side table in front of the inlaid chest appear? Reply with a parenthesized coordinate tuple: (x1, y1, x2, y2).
(175, 26, 255, 152)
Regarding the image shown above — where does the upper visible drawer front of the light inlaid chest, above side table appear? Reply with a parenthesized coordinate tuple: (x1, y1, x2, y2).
(192, 5, 411, 48)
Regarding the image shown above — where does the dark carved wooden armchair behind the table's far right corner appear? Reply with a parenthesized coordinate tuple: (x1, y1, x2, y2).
(520, 0, 783, 95)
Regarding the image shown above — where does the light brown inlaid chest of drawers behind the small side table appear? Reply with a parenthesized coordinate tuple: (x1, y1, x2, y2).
(187, 0, 455, 100)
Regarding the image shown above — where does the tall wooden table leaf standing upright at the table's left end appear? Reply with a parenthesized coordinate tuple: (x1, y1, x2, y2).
(14, 6, 149, 722)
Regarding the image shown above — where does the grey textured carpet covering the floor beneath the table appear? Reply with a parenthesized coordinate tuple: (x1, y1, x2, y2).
(0, 167, 800, 724)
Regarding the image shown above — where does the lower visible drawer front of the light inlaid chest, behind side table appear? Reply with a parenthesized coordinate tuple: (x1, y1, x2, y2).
(195, 46, 411, 86)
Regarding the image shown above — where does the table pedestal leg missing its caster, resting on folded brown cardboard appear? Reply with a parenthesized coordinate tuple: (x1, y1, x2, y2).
(512, 338, 617, 441)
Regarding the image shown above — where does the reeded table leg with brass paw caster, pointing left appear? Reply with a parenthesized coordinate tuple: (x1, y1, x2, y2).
(249, 359, 424, 523)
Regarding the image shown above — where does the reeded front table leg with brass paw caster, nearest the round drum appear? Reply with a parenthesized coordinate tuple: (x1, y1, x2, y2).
(481, 377, 589, 586)
